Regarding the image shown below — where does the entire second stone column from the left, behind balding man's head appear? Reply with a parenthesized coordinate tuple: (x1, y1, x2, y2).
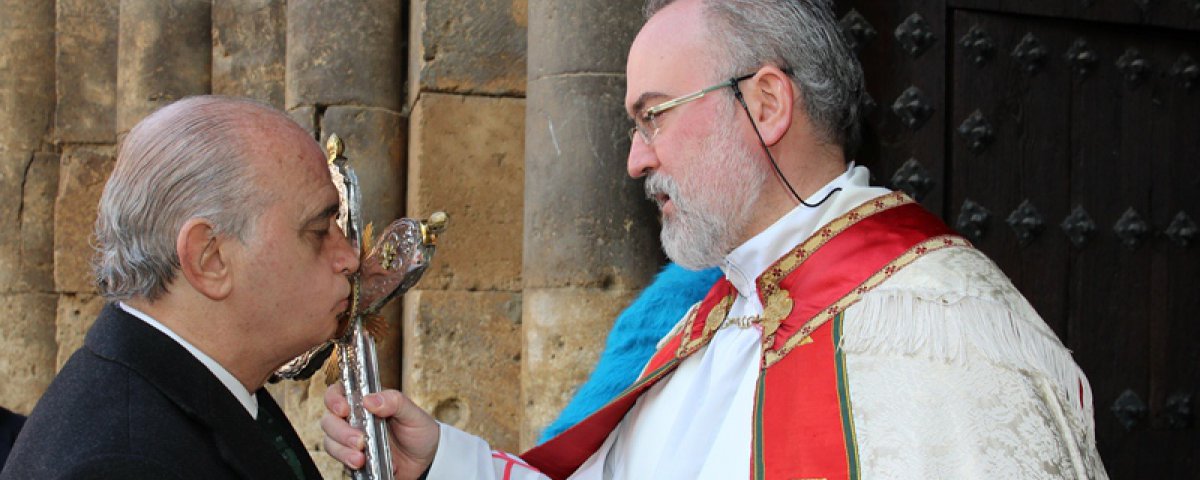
(47, 0, 121, 405)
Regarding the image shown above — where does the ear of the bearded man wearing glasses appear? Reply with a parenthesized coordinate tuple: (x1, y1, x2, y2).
(743, 65, 796, 146)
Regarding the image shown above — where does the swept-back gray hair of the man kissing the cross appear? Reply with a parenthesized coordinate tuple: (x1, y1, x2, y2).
(92, 96, 292, 301)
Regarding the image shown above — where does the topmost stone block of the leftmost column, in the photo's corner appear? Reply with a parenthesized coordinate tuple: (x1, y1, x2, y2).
(0, 0, 54, 152)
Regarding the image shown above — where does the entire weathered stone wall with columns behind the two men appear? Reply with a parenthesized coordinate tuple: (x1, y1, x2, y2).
(0, 0, 661, 478)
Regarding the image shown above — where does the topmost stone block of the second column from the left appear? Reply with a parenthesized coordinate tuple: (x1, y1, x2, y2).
(54, 0, 120, 143)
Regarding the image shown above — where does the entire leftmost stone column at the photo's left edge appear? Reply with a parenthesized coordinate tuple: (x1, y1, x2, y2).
(0, 0, 58, 414)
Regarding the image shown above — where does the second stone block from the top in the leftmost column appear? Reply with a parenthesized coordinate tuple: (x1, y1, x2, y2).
(0, 152, 59, 292)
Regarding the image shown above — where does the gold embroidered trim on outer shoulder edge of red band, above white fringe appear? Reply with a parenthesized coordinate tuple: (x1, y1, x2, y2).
(763, 235, 971, 368)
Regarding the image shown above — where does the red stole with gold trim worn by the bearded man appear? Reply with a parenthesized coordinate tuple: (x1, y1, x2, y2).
(521, 192, 970, 479)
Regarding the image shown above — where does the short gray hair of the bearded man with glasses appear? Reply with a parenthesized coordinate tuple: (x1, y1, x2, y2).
(643, 0, 865, 151)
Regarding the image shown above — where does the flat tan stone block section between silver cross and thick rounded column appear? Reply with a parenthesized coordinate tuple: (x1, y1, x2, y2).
(403, 0, 527, 451)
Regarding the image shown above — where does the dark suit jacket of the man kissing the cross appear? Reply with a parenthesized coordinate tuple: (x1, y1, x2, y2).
(0, 305, 320, 480)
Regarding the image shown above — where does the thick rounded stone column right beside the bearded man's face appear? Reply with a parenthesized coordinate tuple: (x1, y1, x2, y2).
(521, 0, 662, 446)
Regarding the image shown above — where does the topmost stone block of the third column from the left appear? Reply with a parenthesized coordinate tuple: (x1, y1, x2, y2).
(116, 0, 212, 133)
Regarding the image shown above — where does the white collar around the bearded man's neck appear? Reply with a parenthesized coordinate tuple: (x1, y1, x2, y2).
(721, 162, 870, 314)
